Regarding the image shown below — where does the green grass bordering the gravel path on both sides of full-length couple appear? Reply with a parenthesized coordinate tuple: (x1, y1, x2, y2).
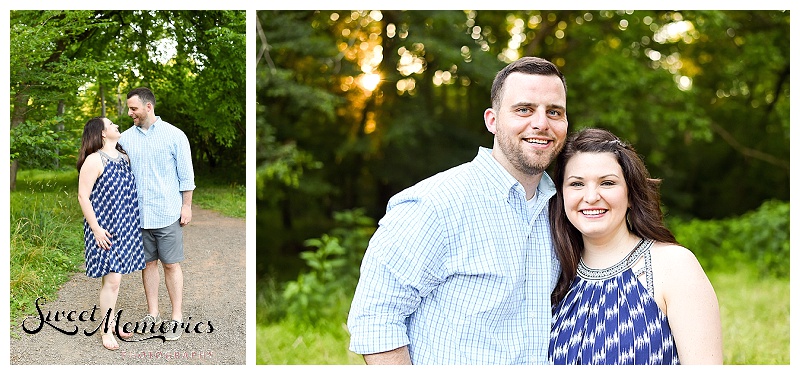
(9, 169, 246, 332)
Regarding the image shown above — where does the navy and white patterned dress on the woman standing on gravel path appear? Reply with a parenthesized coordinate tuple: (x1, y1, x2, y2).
(83, 151, 144, 277)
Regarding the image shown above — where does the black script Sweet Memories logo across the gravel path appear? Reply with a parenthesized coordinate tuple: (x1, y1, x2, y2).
(22, 297, 214, 342)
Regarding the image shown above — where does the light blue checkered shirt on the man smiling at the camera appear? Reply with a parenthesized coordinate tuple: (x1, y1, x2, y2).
(347, 148, 560, 364)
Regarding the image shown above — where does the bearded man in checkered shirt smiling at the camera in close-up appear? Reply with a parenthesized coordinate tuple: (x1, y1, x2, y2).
(348, 57, 568, 365)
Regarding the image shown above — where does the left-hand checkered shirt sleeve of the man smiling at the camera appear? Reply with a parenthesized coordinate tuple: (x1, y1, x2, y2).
(347, 198, 446, 354)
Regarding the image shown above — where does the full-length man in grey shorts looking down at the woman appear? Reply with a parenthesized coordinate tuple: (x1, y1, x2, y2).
(119, 87, 195, 340)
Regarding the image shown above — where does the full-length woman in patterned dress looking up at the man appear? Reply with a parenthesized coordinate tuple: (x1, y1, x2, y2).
(76, 117, 144, 350)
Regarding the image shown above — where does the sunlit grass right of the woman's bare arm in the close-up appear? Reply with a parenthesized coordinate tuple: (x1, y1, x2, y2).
(709, 270, 790, 365)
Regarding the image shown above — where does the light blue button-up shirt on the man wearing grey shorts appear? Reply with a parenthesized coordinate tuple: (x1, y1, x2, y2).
(119, 116, 195, 229)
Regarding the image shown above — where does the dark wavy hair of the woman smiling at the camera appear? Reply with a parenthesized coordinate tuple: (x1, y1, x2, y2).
(550, 128, 678, 305)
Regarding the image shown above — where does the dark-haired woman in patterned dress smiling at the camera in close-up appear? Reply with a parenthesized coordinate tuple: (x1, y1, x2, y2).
(549, 129, 722, 364)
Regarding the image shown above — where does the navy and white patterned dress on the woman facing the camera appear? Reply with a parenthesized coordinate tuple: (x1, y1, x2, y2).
(548, 240, 679, 365)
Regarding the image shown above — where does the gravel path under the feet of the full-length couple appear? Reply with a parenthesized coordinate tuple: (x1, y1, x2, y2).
(9, 206, 247, 365)
